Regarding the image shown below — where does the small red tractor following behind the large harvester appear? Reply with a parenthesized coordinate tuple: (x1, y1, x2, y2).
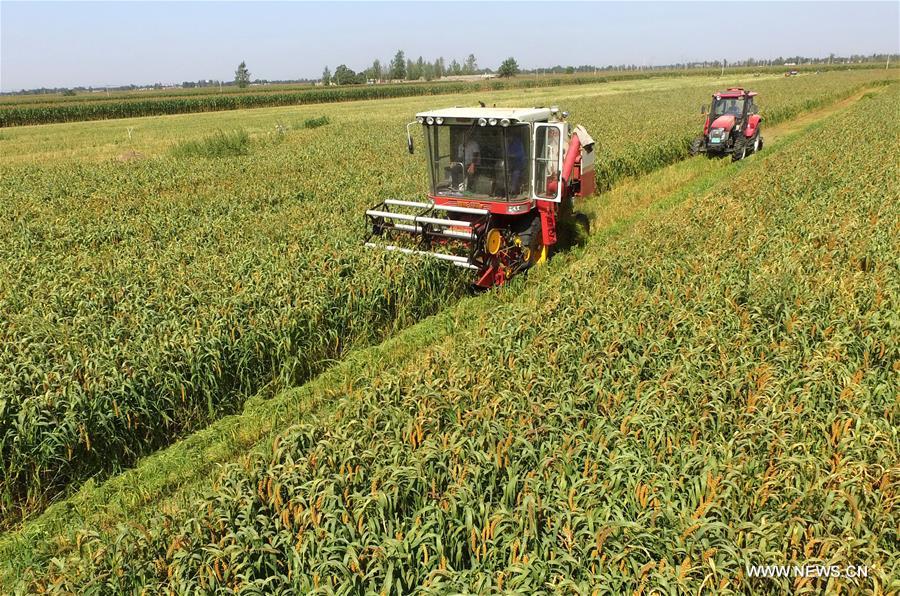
(691, 87, 763, 161)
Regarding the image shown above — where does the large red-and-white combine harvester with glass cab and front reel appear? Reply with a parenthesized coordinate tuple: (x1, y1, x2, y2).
(366, 107, 595, 288)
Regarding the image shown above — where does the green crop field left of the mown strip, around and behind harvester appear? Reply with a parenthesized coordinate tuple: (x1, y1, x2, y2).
(0, 71, 892, 524)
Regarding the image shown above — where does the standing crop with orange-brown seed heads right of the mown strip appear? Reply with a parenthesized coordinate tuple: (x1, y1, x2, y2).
(19, 86, 900, 593)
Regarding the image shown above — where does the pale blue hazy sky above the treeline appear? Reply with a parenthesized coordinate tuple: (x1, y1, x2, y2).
(0, 0, 900, 91)
